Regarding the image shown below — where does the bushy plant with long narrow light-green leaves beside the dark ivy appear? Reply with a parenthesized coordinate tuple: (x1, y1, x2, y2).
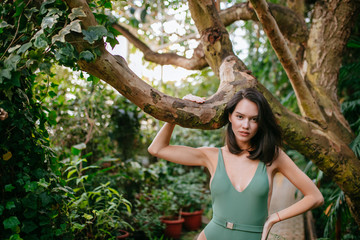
(62, 144, 132, 239)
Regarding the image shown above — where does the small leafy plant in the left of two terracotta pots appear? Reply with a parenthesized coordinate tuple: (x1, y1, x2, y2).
(151, 188, 184, 239)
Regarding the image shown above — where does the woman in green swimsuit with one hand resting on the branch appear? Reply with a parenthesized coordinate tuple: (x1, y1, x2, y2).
(148, 88, 323, 240)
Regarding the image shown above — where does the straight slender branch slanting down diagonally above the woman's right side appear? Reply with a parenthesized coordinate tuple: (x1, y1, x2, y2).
(250, 0, 326, 127)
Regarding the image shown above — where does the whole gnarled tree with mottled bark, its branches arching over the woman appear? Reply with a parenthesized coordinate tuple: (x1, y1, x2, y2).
(62, 0, 360, 225)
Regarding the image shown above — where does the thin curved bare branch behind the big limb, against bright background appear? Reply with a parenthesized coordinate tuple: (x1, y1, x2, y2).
(113, 24, 208, 70)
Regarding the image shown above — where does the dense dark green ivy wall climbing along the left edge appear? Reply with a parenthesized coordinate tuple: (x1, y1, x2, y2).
(0, 1, 73, 239)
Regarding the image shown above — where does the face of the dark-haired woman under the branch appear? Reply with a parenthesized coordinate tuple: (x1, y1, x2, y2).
(229, 98, 259, 149)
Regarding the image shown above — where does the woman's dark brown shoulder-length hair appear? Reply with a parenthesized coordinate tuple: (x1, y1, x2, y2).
(225, 88, 282, 165)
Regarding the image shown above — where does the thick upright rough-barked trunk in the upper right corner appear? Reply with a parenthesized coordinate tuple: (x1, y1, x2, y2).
(306, 0, 360, 143)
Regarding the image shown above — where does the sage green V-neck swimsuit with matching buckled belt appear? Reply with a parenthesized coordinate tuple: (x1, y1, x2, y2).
(204, 149, 269, 240)
